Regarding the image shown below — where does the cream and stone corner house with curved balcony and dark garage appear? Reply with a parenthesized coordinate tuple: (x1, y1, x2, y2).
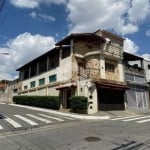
(17, 30, 127, 114)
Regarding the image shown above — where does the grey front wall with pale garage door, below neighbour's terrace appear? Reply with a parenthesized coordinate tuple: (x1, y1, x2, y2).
(125, 70, 149, 108)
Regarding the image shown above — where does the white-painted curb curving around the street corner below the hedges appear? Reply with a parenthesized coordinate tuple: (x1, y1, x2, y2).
(8, 104, 110, 120)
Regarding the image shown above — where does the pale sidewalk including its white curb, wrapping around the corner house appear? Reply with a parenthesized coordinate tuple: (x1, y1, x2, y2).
(9, 104, 150, 120)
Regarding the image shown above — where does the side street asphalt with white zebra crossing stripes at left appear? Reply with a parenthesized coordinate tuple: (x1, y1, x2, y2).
(0, 104, 78, 134)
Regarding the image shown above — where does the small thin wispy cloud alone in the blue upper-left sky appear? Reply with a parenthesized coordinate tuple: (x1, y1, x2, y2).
(29, 11, 56, 22)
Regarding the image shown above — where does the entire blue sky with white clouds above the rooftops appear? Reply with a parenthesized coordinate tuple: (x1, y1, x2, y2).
(0, 0, 150, 80)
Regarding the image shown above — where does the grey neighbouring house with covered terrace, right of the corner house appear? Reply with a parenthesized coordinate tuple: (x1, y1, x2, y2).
(124, 52, 149, 108)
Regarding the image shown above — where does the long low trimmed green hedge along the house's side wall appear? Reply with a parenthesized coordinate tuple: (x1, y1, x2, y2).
(13, 96, 60, 110)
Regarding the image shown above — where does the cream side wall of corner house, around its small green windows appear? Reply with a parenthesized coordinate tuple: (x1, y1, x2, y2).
(20, 56, 72, 95)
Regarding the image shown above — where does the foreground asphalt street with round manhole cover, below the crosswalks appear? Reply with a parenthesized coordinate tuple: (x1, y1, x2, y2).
(0, 117, 150, 150)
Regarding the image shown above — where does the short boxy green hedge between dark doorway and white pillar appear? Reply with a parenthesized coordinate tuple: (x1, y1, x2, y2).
(70, 96, 87, 113)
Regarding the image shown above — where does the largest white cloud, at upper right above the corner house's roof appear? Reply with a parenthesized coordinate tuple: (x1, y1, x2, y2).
(66, 0, 150, 35)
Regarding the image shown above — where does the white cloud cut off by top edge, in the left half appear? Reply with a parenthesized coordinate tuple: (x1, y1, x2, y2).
(10, 0, 66, 9)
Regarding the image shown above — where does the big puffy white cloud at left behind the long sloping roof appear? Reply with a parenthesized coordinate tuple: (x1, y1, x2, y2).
(0, 33, 55, 80)
